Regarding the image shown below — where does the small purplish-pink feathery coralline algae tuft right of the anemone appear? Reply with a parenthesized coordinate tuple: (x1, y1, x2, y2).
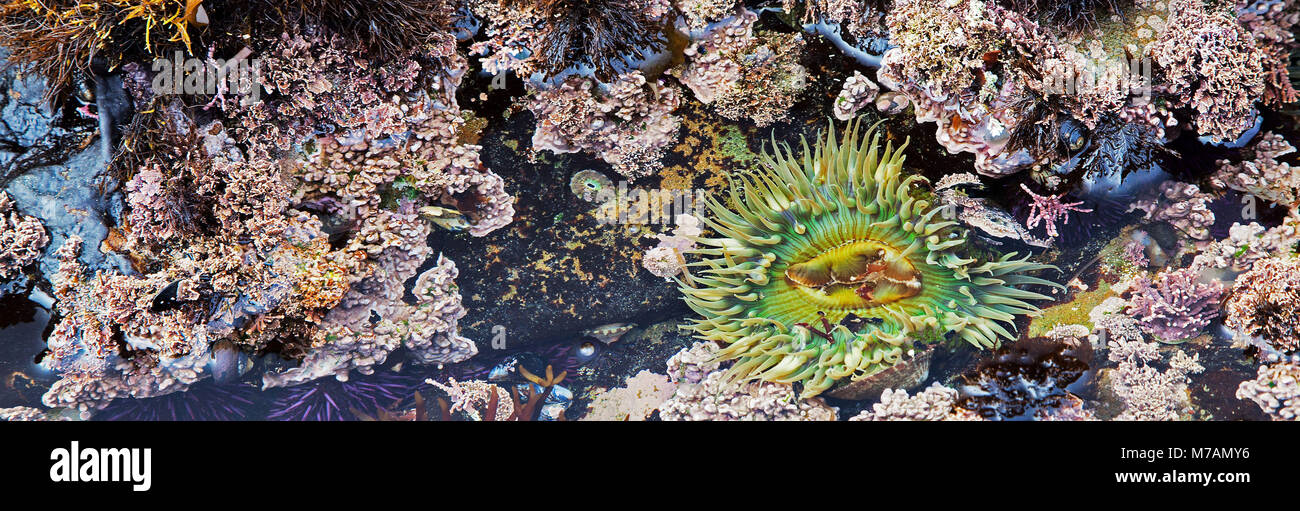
(1125, 268, 1223, 342)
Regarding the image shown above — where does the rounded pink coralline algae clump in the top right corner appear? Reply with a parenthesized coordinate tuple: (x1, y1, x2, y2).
(1151, 0, 1264, 142)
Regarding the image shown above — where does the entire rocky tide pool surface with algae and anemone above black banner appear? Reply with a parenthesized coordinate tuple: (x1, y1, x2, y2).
(0, 0, 1300, 420)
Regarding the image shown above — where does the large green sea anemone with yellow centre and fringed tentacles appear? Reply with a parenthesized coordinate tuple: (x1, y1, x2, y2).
(679, 122, 1060, 397)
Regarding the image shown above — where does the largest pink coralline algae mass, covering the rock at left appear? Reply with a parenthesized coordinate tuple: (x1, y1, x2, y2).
(30, 19, 514, 413)
